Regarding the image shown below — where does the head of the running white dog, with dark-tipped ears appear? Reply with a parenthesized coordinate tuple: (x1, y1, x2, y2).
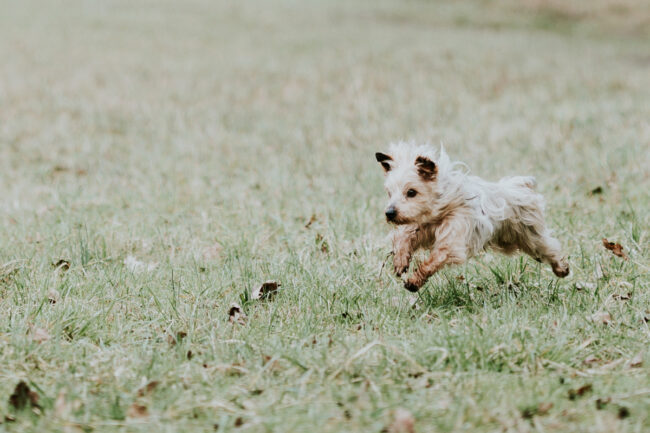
(375, 143, 438, 225)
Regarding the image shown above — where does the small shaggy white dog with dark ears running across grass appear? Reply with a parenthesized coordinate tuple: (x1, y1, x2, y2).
(375, 142, 569, 292)
